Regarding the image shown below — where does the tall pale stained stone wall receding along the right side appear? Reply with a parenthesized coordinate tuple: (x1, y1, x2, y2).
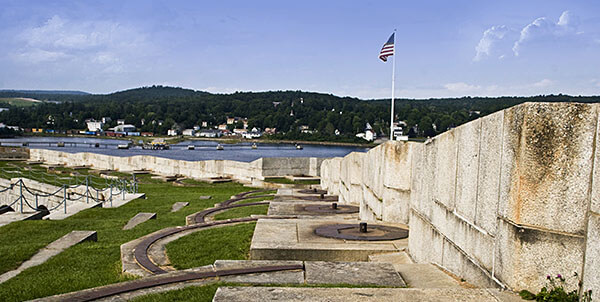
(321, 103, 600, 292)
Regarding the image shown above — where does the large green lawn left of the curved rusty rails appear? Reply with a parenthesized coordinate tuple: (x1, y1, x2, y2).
(0, 183, 248, 301)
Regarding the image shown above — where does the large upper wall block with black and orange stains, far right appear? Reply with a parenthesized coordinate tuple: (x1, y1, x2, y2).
(500, 103, 597, 234)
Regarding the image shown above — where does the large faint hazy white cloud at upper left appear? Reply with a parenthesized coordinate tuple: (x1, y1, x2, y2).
(11, 15, 151, 73)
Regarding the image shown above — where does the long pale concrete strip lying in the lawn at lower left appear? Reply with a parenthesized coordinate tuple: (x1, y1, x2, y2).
(0, 231, 98, 283)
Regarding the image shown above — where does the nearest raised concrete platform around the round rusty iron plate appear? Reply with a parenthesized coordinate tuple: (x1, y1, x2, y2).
(250, 219, 408, 261)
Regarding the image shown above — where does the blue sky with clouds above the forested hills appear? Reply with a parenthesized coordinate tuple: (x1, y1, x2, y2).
(0, 0, 600, 98)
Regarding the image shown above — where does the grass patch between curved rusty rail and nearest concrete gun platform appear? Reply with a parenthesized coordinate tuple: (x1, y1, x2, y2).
(166, 223, 256, 269)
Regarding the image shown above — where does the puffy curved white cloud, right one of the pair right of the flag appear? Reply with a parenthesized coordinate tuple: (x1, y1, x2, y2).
(512, 11, 582, 56)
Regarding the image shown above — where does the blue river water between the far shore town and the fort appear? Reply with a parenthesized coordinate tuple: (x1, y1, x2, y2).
(0, 137, 368, 162)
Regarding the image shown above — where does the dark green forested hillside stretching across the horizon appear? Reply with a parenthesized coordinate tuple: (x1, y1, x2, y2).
(0, 86, 600, 141)
